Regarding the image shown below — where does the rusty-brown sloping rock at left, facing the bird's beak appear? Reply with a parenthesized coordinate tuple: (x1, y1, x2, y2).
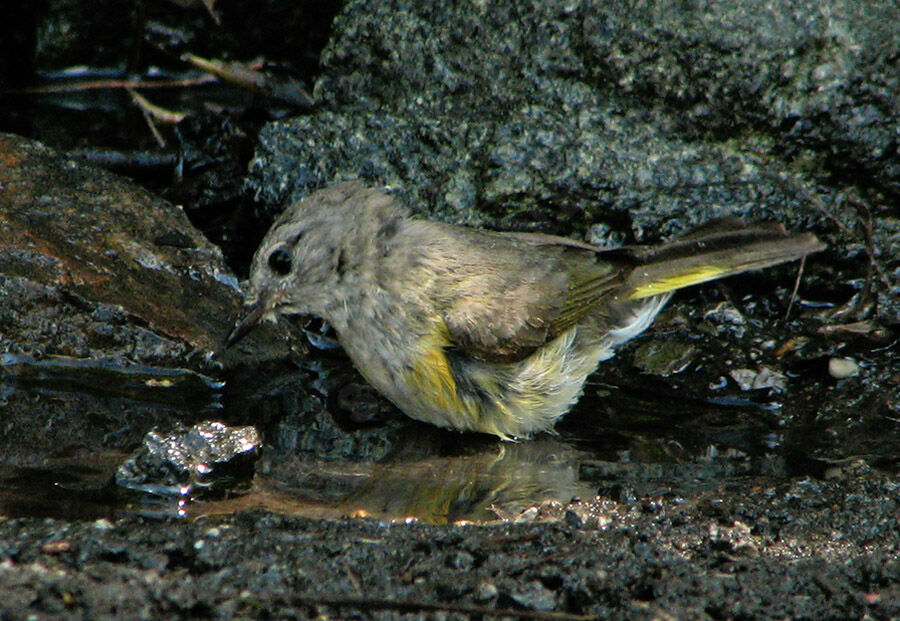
(0, 135, 241, 368)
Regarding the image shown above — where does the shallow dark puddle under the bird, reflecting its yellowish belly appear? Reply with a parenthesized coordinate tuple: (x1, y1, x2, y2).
(0, 348, 876, 523)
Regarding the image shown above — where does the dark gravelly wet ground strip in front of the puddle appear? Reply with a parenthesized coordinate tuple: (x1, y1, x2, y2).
(0, 462, 900, 619)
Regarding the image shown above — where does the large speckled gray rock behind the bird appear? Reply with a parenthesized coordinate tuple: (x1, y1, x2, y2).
(253, 0, 900, 232)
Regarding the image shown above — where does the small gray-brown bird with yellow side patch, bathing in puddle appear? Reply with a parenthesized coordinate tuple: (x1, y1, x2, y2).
(226, 182, 824, 439)
